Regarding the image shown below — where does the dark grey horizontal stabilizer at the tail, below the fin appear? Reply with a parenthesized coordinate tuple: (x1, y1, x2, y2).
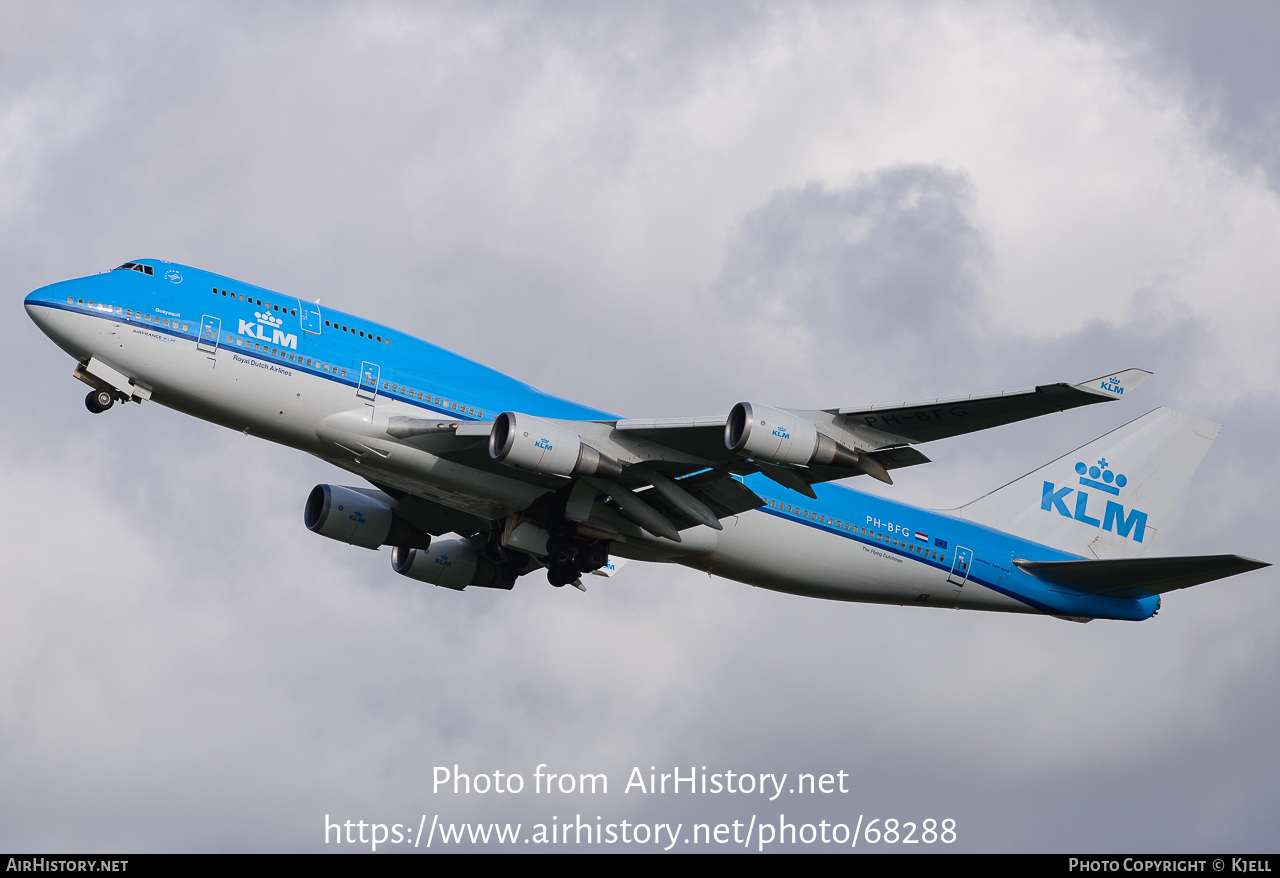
(1014, 555, 1271, 598)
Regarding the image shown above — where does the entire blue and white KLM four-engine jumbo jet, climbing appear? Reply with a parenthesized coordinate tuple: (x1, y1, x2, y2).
(26, 260, 1267, 622)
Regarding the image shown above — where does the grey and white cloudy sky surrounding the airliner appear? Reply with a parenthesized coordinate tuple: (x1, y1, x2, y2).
(0, 3, 1280, 851)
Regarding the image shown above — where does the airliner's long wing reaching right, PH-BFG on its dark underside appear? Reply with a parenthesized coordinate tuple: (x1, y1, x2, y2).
(345, 369, 1149, 540)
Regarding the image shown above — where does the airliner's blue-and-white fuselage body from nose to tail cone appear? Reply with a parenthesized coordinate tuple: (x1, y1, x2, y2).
(26, 260, 1259, 619)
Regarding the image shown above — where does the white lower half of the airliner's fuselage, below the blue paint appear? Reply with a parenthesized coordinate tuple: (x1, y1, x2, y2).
(32, 307, 1038, 613)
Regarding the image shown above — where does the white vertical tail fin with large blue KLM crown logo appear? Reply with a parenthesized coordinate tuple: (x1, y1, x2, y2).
(956, 408, 1222, 558)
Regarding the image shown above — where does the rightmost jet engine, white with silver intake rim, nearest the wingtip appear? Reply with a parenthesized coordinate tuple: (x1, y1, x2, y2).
(724, 402, 861, 468)
